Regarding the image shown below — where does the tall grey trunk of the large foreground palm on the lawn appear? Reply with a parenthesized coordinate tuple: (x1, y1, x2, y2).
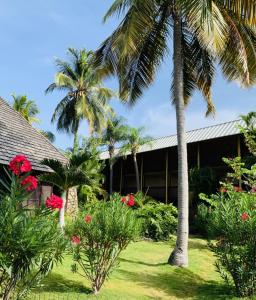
(168, 13, 189, 266)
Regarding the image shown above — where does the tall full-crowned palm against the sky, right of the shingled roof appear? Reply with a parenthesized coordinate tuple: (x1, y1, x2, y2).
(46, 48, 114, 152)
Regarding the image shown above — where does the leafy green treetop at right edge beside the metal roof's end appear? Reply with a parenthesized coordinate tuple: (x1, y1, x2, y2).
(239, 111, 256, 156)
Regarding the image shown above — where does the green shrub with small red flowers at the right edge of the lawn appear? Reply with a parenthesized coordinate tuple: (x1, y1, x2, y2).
(202, 187, 256, 296)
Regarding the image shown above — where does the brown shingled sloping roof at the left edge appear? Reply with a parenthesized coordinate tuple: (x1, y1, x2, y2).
(0, 98, 67, 171)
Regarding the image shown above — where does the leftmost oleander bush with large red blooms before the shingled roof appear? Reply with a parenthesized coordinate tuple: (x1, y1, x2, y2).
(0, 157, 66, 300)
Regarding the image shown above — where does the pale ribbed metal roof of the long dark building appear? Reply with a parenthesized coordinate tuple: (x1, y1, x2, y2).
(100, 120, 242, 159)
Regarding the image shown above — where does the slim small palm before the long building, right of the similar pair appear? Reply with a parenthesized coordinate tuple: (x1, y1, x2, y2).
(120, 127, 152, 192)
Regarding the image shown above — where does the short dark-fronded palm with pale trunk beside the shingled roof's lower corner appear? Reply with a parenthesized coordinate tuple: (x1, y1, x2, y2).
(39, 152, 90, 228)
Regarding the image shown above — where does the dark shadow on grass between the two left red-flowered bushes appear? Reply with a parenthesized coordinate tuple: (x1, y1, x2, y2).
(35, 273, 91, 294)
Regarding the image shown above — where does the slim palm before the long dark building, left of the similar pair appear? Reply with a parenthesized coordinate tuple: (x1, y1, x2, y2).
(102, 116, 128, 195)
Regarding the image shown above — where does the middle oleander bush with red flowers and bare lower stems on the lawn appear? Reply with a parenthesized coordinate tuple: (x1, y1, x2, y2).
(69, 198, 139, 293)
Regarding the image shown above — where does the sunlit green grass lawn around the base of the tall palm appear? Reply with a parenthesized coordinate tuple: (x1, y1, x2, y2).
(31, 238, 246, 300)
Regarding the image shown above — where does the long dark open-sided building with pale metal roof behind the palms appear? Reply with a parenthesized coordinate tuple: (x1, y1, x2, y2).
(101, 120, 248, 203)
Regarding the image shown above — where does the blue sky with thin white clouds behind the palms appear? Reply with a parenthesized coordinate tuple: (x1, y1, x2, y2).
(0, 0, 256, 148)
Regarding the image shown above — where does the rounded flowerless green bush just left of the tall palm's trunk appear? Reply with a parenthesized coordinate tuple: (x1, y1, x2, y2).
(137, 201, 178, 241)
